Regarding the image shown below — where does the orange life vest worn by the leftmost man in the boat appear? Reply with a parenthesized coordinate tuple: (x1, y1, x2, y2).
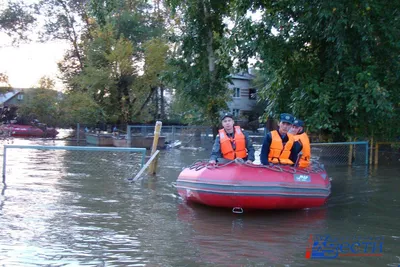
(219, 126, 247, 160)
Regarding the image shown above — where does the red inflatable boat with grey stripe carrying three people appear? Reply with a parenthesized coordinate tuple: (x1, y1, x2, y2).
(176, 162, 331, 212)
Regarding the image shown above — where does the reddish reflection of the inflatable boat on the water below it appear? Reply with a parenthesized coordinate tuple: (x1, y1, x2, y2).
(178, 204, 326, 266)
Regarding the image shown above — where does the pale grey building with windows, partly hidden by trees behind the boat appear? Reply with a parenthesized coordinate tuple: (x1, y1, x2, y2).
(228, 72, 257, 119)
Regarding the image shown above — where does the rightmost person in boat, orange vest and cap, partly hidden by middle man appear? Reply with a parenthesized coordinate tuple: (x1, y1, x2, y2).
(289, 119, 311, 168)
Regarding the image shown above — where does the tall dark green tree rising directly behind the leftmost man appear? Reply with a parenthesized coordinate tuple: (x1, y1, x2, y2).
(169, 0, 232, 134)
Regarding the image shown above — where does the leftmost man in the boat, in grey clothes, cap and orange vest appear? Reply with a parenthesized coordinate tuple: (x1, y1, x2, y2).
(209, 113, 255, 164)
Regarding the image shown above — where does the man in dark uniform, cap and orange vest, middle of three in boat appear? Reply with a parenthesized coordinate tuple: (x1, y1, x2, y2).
(260, 113, 300, 168)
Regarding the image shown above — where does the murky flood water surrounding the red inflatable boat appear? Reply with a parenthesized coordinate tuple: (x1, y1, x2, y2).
(0, 135, 400, 266)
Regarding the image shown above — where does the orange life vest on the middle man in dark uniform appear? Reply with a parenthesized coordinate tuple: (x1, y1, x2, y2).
(268, 130, 294, 164)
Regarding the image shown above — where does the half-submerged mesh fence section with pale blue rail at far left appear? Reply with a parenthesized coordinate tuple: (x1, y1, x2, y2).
(3, 145, 146, 183)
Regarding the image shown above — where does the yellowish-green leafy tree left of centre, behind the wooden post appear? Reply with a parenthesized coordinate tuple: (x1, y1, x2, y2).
(60, 0, 170, 123)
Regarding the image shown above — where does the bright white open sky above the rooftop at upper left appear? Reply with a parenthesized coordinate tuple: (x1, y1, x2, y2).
(0, 32, 68, 91)
